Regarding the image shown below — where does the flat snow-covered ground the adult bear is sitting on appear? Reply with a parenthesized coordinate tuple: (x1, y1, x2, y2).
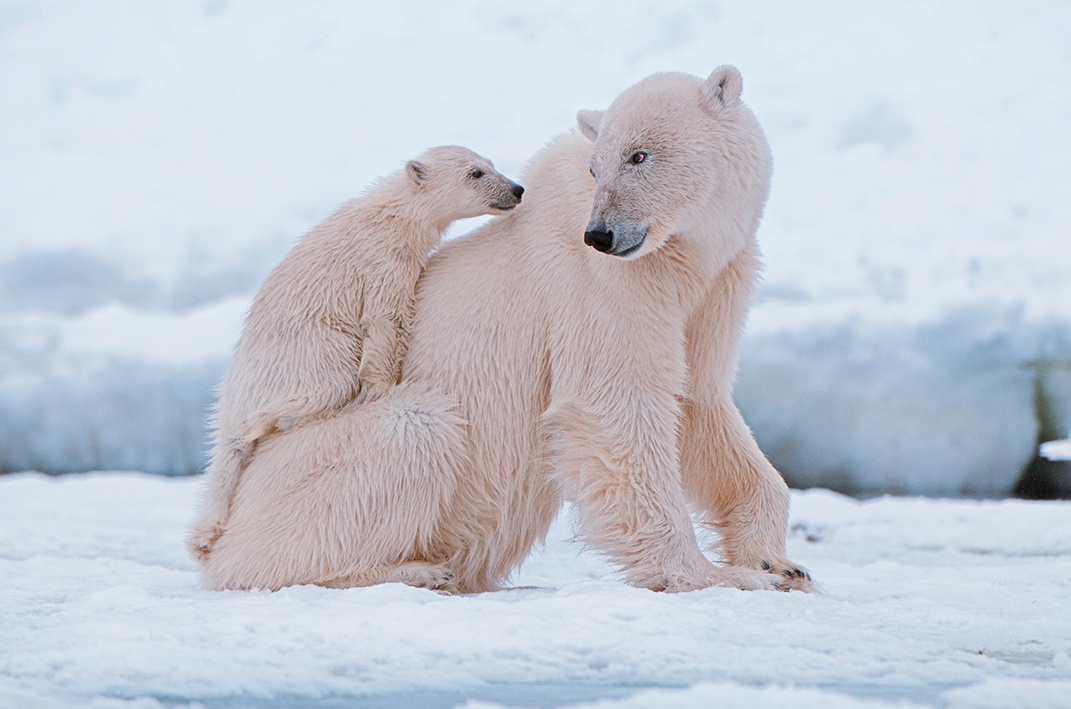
(0, 472, 1071, 709)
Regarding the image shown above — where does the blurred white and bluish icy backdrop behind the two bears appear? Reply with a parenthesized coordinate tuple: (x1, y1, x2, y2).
(0, 0, 1071, 496)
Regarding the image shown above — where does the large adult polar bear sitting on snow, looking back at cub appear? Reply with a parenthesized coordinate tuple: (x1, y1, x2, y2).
(201, 66, 811, 592)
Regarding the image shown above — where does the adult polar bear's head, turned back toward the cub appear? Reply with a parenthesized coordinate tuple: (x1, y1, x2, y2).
(577, 65, 772, 263)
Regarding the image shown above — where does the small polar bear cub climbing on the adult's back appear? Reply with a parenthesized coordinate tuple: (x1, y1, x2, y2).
(188, 146, 524, 557)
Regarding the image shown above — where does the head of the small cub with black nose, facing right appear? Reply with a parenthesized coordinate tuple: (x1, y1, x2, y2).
(405, 146, 525, 221)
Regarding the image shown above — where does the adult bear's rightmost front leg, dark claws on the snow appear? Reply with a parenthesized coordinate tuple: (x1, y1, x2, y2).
(681, 397, 817, 591)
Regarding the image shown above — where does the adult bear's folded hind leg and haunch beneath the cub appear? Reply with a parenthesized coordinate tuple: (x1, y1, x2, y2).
(200, 384, 467, 590)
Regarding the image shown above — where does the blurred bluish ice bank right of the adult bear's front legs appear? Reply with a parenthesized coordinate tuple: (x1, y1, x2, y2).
(736, 306, 1071, 497)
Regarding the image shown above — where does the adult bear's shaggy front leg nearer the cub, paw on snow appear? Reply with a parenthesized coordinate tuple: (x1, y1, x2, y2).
(544, 403, 781, 591)
